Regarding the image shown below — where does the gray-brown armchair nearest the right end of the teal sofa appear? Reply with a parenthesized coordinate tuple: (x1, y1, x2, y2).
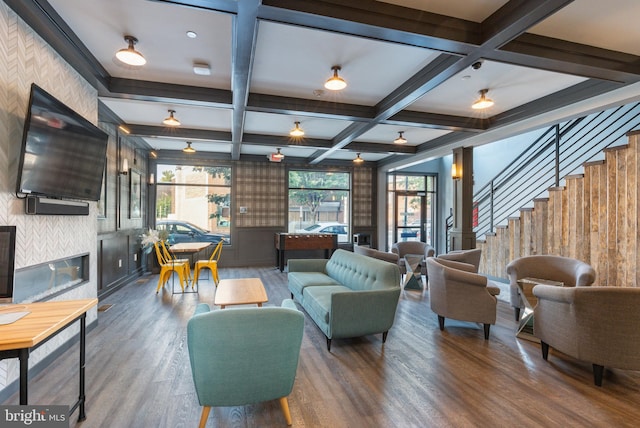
(427, 257, 500, 339)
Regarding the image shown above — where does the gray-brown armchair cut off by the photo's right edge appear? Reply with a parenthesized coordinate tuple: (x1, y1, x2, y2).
(533, 285, 640, 386)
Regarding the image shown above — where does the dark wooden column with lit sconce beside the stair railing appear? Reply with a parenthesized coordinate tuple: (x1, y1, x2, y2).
(450, 147, 476, 250)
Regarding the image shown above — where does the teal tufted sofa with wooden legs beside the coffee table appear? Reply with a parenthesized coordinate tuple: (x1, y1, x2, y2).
(288, 250, 400, 351)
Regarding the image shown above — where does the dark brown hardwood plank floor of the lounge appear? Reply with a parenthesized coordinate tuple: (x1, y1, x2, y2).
(4, 268, 640, 428)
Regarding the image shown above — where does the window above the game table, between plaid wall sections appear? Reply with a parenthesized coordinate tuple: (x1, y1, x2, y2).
(288, 170, 351, 242)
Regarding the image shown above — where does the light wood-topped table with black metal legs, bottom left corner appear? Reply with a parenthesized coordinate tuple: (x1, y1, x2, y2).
(0, 299, 98, 421)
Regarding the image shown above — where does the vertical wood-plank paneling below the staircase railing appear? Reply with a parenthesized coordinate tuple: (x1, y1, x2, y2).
(477, 131, 640, 287)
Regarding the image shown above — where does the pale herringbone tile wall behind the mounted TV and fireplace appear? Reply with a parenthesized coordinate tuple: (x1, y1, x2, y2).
(0, 2, 98, 388)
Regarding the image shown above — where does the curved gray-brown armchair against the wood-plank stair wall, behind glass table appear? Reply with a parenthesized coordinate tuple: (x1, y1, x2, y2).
(507, 255, 596, 321)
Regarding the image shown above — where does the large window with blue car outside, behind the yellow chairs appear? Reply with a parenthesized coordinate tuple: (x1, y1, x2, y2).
(156, 165, 232, 243)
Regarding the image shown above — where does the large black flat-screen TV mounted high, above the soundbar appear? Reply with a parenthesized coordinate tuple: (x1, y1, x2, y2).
(16, 84, 108, 201)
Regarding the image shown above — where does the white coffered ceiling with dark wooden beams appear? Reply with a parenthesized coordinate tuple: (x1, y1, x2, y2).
(11, 0, 640, 166)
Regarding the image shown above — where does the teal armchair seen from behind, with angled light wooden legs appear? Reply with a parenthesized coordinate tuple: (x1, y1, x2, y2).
(187, 299, 304, 427)
